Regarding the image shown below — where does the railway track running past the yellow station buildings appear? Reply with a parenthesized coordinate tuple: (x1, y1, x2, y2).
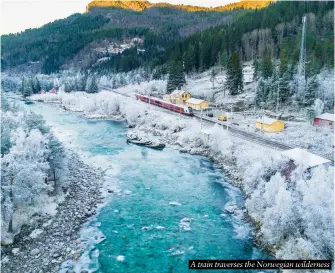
(103, 86, 334, 166)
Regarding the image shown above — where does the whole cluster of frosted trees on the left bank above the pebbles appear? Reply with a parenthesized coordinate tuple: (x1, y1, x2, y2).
(1, 99, 66, 242)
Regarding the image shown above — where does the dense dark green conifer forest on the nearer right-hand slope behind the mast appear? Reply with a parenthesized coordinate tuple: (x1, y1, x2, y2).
(167, 1, 334, 72)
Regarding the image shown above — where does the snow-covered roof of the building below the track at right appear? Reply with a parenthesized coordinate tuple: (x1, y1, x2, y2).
(281, 148, 330, 168)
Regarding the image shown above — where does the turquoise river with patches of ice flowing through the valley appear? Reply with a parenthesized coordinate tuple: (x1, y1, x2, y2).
(28, 103, 269, 273)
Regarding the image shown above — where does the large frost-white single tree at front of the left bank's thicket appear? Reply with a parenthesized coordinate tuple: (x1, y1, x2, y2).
(1, 128, 51, 232)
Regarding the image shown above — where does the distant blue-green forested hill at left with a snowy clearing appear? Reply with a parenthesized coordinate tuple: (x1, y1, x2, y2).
(1, 1, 269, 73)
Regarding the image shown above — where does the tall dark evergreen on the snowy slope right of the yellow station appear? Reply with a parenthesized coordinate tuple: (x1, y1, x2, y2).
(225, 51, 243, 95)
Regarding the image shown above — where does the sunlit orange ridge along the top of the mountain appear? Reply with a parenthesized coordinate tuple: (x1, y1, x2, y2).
(86, 0, 273, 12)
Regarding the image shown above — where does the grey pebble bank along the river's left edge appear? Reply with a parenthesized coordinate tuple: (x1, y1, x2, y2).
(1, 151, 103, 273)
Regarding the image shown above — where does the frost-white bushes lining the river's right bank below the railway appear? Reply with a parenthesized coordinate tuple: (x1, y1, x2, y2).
(28, 92, 334, 266)
